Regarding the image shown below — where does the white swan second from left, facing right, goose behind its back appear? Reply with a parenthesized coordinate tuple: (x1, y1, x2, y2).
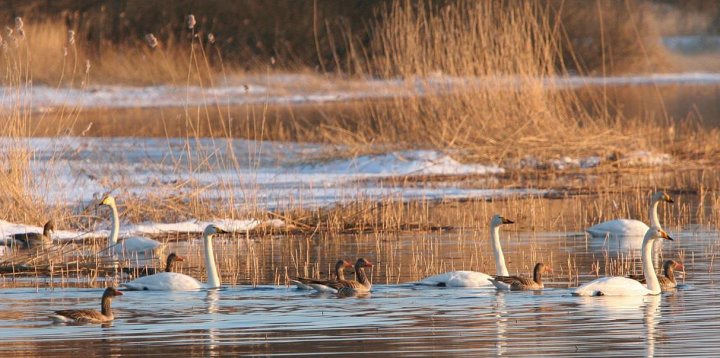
(122, 224, 227, 291)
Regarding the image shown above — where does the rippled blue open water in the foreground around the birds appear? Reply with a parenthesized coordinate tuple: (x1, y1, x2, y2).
(0, 230, 720, 357)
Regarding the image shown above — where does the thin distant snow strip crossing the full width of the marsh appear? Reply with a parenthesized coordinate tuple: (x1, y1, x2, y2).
(0, 72, 720, 112)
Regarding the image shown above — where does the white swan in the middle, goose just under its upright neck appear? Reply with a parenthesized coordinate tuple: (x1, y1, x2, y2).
(415, 214, 515, 287)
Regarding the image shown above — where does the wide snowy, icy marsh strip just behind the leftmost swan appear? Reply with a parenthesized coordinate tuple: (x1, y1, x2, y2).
(0, 137, 673, 209)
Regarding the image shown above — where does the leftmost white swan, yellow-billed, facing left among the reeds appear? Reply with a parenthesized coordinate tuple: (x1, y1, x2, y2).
(98, 195, 163, 258)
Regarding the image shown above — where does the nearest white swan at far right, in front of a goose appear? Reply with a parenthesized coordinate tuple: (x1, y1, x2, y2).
(572, 227, 672, 296)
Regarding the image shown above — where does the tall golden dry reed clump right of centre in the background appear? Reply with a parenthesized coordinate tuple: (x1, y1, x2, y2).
(306, 1, 626, 162)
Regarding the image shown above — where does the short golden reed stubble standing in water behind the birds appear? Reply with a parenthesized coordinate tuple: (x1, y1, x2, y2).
(0, 187, 720, 286)
